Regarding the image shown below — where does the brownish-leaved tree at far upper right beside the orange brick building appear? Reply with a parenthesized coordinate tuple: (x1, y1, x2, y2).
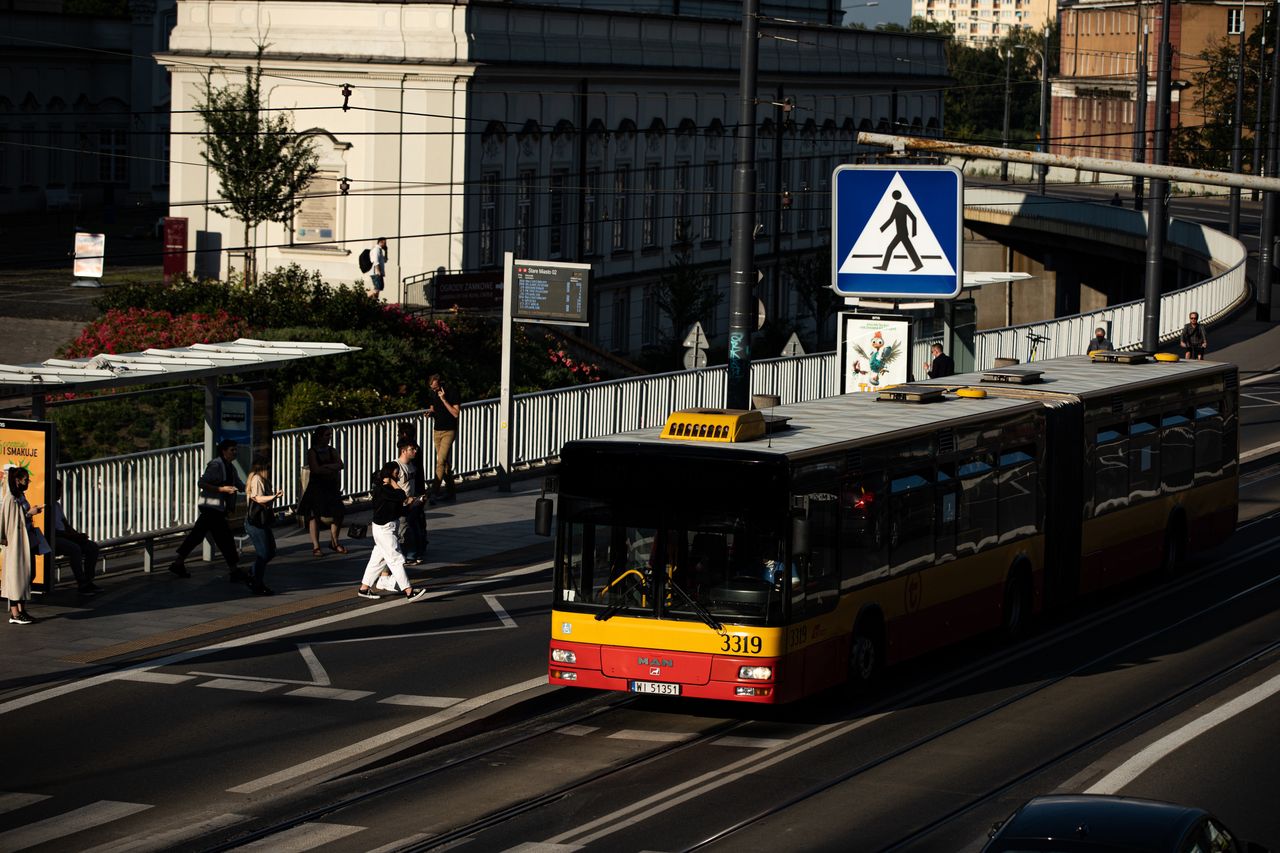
(1169, 24, 1262, 170)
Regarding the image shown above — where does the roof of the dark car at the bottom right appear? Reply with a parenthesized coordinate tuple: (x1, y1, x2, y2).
(996, 794, 1207, 852)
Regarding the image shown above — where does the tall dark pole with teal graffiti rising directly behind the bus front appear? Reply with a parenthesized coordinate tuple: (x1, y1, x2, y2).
(724, 0, 757, 409)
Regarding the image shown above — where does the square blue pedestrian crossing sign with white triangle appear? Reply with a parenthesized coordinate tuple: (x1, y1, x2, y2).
(831, 165, 964, 298)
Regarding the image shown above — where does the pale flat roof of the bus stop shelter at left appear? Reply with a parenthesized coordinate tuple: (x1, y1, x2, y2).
(0, 338, 360, 397)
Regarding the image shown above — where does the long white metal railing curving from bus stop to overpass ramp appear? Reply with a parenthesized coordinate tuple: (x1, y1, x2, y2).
(59, 191, 1248, 542)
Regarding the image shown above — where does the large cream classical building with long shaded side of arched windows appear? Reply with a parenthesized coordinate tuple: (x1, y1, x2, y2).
(159, 0, 947, 353)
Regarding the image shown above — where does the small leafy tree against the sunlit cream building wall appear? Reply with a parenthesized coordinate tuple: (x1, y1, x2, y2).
(196, 45, 319, 281)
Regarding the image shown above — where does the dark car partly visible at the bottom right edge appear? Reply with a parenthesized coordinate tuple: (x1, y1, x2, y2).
(982, 794, 1267, 853)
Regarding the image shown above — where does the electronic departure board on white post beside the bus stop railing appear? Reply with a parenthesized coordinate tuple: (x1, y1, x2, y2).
(498, 252, 591, 492)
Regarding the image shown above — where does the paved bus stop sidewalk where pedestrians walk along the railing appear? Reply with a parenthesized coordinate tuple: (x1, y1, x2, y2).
(0, 480, 552, 697)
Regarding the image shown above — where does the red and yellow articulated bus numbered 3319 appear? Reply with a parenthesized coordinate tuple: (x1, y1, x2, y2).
(539, 352, 1239, 703)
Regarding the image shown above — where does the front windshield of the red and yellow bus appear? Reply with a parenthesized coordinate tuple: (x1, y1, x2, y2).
(556, 496, 790, 624)
